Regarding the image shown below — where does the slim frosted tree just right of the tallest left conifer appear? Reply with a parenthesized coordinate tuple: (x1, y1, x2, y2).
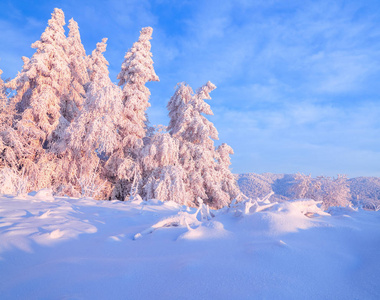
(64, 19, 90, 122)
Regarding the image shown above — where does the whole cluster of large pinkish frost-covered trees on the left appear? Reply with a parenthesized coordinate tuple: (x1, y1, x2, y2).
(0, 8, 239, 208)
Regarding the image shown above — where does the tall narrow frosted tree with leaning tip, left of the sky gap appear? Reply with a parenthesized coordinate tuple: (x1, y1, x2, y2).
(107, 27, 159, 199)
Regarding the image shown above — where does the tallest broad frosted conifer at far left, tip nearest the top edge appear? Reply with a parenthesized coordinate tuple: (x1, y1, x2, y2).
(7, 8, 71, 148)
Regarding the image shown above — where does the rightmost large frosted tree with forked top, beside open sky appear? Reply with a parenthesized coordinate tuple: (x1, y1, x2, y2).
(168, 82, 238, 207)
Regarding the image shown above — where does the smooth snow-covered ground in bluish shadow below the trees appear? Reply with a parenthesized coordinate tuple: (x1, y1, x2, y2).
(0, 190, 380, 299)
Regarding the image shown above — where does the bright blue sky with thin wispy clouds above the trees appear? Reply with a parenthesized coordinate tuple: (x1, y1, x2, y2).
(0, 0, 380, 177)
